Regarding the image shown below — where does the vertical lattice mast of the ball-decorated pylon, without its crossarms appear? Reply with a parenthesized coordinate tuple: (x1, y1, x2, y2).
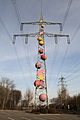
(34, 18, 48, 106)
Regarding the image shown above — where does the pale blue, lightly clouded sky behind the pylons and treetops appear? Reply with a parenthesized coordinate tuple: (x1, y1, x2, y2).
(0, 0, 80, 98)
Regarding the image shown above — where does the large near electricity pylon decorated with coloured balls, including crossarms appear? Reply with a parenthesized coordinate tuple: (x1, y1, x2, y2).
(13, 16, 70, 106)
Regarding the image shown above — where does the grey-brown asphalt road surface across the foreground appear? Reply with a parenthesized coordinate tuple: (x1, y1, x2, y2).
(0, 111, 80, 120)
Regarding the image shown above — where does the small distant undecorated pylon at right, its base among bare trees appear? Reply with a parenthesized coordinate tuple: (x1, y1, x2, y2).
(58, 76, 67, 105)
